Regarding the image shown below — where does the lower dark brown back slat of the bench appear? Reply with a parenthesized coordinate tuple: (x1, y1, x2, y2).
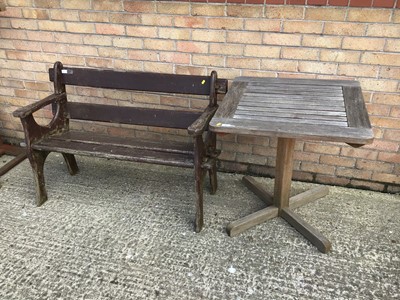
(67, 102, 201, 129)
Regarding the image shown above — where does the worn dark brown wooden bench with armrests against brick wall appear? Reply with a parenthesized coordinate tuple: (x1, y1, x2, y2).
(14, 62, 227, 232)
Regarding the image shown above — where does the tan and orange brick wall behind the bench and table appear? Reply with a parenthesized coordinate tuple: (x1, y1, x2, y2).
(0, 0, 400, 192)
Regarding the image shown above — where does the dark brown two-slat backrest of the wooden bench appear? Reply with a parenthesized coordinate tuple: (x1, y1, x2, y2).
(49, 62, 227, 129)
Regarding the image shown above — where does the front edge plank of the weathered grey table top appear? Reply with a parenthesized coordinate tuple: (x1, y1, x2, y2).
(210, 117, 374, 144)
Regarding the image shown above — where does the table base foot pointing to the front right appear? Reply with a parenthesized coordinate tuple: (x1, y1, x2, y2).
(281, 208, 332, 253)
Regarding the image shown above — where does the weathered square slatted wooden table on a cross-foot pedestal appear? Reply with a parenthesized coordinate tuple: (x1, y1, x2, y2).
(210, 77, 373, 253)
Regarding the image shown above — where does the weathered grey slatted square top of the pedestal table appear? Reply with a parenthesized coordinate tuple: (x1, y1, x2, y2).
(210, 77, 374, 145)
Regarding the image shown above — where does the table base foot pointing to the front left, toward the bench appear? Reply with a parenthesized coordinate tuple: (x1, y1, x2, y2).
(226, 206, 279, 237)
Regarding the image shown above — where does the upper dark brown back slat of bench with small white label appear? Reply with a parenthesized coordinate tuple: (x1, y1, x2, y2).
(49, 67, 211, 95)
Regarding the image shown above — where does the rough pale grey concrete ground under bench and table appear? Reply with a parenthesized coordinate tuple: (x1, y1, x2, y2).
(0, 154, 400, 300)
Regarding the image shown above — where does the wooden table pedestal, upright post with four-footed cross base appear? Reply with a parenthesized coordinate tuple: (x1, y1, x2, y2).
(227, 138, 331, 253)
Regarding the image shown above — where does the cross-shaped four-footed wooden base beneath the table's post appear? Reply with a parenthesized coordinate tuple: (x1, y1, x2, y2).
(226, 176, 331, 253)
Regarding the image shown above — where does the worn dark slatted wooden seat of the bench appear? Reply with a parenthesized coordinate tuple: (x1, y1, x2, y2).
(32, 132, 194, 168)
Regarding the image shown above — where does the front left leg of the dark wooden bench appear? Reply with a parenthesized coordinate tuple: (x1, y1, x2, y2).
(29, 151, 49, 206)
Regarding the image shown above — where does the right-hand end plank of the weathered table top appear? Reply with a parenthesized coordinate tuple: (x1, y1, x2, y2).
(343, 87, 371, 128)
